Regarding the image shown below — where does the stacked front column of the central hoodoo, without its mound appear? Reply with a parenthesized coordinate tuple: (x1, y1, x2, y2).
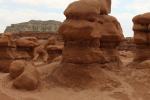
(59, 1, 105, 64)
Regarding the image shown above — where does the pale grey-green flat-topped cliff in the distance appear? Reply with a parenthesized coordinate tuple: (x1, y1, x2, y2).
(5, 20, 61, 33)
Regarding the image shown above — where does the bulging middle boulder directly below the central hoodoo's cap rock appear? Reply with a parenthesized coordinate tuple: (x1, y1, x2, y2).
(59, 19, 100, 40)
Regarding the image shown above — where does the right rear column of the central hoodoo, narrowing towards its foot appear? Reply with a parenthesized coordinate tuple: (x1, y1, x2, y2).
(99, 15, 124, 67)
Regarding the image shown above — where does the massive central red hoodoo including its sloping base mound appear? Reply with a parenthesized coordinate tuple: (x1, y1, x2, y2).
(51, 0, 123, 88)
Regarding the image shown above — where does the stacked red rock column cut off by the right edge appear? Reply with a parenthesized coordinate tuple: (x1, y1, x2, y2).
(133, 13, 150, 61)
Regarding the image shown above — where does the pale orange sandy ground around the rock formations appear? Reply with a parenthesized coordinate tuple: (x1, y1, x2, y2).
(0, 51, 150, 100)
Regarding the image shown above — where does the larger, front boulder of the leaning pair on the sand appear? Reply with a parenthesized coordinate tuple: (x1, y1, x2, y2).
(13, 63, 39, 90)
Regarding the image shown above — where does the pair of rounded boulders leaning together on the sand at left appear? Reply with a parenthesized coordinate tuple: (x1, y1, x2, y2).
(10, 60, 39, 90)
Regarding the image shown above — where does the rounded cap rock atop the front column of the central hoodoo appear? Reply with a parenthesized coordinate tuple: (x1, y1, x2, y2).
(64, 0, 100, 18)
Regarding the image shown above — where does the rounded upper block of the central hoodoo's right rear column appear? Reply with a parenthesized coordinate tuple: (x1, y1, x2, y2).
(98, 15, 124, 42)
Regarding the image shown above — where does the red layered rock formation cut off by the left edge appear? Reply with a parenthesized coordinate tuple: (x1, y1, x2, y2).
(0, 33, 18, 72)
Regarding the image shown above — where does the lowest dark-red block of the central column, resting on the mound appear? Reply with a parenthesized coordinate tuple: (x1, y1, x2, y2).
(63, 42, 105, 64)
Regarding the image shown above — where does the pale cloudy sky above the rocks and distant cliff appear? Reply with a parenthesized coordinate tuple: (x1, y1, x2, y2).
(0, 0, 150, 37)
